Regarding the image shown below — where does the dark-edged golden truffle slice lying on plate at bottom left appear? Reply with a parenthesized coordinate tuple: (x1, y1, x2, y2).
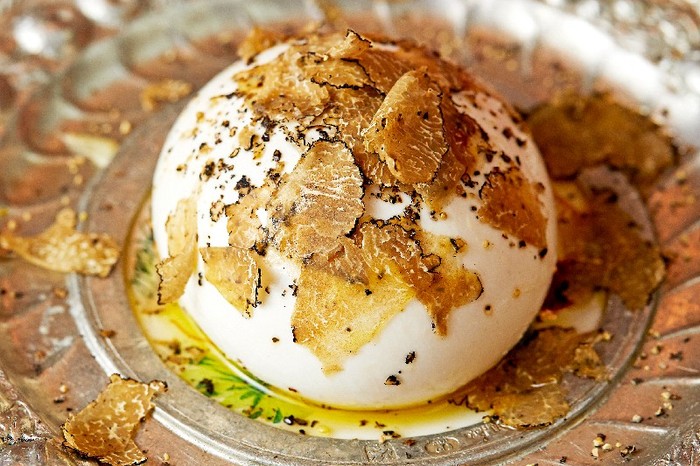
(61, 374, 166, 466)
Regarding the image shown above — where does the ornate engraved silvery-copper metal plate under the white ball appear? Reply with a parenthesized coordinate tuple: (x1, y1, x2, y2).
(0, 0, 700, 465)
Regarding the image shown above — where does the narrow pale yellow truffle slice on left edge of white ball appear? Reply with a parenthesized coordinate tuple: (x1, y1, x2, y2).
(156, 197, 197, 304)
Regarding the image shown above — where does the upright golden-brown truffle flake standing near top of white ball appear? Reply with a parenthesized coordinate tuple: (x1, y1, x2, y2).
(363, 70, 447, 184)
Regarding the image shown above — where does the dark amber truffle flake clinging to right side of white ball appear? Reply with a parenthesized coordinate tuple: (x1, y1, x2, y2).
(478, 167, 547, 250)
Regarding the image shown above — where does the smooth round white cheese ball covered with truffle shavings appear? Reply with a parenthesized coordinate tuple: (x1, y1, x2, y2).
(152, 41, 557, 409)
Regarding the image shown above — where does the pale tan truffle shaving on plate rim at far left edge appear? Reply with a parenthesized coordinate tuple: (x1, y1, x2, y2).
(0, 208, 119, 277)
